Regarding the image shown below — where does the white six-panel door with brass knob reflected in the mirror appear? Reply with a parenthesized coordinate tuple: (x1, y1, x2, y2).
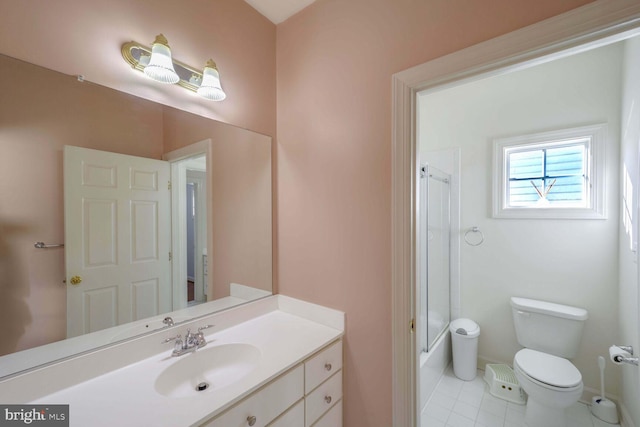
(64, 146, 172, 337)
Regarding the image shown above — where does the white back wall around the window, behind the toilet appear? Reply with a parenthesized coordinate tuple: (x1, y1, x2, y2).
(419, 45, 622, 398)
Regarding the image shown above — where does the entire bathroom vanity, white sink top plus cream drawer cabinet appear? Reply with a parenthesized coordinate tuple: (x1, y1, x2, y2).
(8, 295, 345, 427)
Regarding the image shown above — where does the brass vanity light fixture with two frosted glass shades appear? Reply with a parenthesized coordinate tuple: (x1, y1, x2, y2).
(121, 34, 227, 101)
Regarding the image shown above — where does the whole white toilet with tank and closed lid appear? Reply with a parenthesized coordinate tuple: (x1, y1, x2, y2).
(511, 297, 588, 427)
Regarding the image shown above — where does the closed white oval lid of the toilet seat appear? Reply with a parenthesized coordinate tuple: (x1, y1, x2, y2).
(514, 348, 582, 388)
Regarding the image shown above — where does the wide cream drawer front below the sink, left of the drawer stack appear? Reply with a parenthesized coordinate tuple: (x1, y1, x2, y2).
(204, 365, 304, 427)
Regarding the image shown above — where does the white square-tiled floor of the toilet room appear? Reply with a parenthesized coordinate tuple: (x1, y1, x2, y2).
(420, 367, 619, 427)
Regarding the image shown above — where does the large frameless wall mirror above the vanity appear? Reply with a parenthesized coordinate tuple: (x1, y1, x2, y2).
(0, 55, 272, 377)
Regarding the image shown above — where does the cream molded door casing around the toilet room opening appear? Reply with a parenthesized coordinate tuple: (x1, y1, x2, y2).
(391, 0, 640, 427)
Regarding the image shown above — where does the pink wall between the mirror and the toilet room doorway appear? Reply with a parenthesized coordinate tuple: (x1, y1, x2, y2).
(277, 0, 589, 427)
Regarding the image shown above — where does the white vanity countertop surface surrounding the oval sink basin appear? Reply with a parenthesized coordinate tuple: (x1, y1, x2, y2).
(32, 297, 344, 427)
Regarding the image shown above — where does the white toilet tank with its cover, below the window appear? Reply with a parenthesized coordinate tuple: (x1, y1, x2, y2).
(511, 297, 588, 359)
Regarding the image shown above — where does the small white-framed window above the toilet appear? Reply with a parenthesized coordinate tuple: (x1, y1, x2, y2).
(493, 125, 606, 218)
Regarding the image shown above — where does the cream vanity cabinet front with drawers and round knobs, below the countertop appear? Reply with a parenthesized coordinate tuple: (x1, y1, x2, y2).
(202, 340, 342, 427)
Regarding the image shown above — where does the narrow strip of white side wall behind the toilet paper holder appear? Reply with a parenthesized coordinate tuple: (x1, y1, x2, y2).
(617, 37, 640, 425)
